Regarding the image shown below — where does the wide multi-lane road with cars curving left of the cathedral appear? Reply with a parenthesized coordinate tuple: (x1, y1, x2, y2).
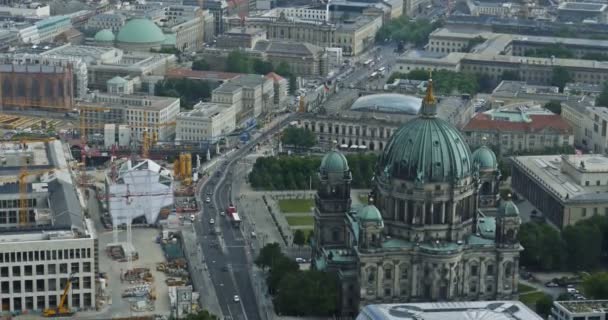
(195, 114, 299, 320)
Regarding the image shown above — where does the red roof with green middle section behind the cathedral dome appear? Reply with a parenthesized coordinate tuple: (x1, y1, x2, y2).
(464, 113, 572, 133)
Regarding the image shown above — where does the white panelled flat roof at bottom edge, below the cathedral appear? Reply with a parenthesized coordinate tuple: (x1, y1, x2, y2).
(356, 301, 543, 320)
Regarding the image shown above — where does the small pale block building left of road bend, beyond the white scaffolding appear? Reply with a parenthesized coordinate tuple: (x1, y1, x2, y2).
(175, 102, 236, 143)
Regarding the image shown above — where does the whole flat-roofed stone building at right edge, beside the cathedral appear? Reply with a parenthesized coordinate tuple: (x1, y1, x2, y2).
(511, 154, 608, 229)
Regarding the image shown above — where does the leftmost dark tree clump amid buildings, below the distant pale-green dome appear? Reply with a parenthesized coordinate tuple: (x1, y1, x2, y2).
(154, 78, 211, 108)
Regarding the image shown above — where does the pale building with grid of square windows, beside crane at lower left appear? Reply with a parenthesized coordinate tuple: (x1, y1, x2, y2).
(0, 141, 99, 314)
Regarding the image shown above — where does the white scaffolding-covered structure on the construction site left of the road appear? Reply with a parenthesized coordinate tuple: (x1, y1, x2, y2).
(108, 160, 173, 224)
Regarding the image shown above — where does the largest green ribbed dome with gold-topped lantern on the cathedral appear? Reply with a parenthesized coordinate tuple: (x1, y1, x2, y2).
(377, 80, 472, 183)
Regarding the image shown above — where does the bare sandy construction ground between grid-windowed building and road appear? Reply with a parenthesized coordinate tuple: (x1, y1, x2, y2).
(99, 228, 170, 318)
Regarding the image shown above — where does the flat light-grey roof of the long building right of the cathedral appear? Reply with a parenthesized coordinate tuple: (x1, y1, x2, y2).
(512, 154, 608, 202)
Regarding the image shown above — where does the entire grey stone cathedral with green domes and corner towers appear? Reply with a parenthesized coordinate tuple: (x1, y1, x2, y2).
(312, 82, 522, 316)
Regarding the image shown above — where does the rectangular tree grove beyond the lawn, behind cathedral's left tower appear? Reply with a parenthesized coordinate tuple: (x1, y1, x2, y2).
(249, 153, 377, 190)
